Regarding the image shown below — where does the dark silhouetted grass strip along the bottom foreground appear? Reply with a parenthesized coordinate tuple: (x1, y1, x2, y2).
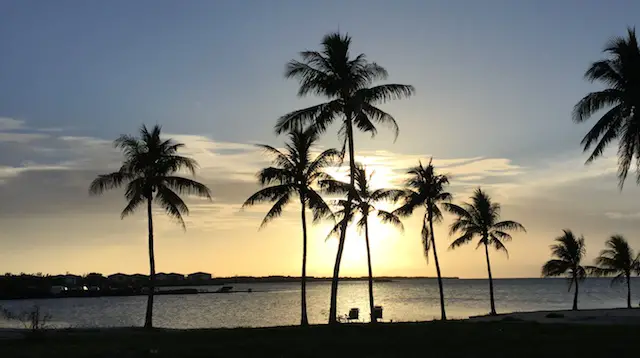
(0, 322, 640, 358)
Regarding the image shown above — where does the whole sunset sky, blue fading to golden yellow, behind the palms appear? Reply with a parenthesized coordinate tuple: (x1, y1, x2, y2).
(0, 0, 640, 278)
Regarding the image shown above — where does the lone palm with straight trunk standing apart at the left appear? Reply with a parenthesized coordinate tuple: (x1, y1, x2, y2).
(89, 125, 211, 328)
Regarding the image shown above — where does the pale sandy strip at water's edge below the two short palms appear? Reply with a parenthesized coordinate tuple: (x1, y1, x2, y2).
(467, 308, 640, 324)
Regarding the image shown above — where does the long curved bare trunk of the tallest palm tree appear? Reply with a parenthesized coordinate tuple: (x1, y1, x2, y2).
(329, 113, 356, 324)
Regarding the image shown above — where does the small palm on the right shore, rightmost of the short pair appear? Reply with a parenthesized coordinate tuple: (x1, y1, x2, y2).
(589, 235, 640, 308)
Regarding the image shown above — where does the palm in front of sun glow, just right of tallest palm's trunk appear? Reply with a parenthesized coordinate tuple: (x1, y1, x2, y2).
(320, 164, 403, 322)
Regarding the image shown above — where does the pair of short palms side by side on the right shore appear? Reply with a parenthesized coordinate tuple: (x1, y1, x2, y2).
(542, 229, 640, 310)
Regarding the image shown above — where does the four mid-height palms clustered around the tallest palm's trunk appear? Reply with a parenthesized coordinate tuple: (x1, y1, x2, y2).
(243, 126, 524, 325)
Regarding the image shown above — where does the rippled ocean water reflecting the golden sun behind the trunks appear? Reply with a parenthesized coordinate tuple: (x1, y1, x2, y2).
(0, 278, 640, 328)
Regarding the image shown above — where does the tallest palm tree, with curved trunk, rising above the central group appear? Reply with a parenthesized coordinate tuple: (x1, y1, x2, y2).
(275, 33, 415, 323)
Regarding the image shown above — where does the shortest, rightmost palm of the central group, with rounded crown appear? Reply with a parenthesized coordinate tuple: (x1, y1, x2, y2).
(443, 188, 526, 315)
